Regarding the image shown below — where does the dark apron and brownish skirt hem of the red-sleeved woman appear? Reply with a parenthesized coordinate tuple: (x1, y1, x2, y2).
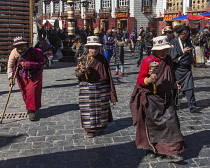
(136, 92, 186, 155)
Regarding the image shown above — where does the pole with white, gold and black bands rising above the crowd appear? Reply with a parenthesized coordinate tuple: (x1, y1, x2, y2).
(67, 0, 75, 35)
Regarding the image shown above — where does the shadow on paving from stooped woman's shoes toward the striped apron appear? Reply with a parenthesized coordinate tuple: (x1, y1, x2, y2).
(38, 104, 79, 120)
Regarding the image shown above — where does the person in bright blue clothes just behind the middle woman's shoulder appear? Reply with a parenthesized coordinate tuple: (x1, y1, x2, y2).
(103, 29, 114, 63)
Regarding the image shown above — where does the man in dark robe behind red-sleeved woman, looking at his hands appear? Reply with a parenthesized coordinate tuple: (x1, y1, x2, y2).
(169, 26, 200, 113)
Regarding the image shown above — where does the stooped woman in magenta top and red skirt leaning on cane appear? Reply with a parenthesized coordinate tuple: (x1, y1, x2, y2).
(7, 36, 44, 121)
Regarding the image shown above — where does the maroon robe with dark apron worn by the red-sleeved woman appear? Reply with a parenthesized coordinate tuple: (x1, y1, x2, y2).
(130, 56, 186, 155)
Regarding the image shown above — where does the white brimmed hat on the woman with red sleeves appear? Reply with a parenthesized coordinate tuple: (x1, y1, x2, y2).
(151, 36, 172, 50)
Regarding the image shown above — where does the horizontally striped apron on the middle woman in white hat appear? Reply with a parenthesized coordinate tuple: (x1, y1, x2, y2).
(79, 82, 110, 129)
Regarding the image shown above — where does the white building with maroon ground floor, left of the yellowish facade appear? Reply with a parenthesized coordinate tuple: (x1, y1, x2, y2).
(39, 0, 164, 30)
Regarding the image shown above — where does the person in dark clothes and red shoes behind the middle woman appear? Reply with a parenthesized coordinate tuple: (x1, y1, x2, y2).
(113, 37, 124, 75)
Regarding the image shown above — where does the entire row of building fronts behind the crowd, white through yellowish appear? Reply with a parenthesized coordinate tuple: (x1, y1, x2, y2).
(37, 0, 209, 34)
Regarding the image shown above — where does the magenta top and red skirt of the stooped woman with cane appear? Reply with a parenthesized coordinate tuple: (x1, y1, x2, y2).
(16, 47, 44, 111)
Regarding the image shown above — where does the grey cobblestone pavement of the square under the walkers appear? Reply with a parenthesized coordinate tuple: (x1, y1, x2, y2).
(0, 48, 210, 168)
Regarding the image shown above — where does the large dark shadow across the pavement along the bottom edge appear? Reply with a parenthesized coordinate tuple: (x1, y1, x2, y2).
(0, 142, 144, 168)
